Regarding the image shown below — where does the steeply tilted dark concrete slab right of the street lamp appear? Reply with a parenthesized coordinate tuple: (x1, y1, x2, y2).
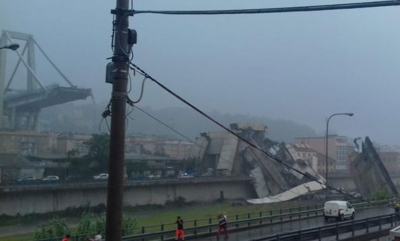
(350, 137, 398, 197)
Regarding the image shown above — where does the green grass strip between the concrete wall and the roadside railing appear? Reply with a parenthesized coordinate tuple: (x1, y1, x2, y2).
(0, 202, 321, 241)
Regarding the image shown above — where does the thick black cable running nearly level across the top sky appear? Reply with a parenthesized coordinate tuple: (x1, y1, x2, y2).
(130, 0, 400, 15)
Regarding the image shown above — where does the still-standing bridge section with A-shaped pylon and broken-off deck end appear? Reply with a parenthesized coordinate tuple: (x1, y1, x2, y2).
(0, 30, 92, 131)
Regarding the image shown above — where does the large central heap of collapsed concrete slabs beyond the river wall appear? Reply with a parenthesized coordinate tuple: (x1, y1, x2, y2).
(196, 123, 325, 203)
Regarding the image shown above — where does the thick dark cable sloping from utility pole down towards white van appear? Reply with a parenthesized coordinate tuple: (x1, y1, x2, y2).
(130, 62, 355, 198)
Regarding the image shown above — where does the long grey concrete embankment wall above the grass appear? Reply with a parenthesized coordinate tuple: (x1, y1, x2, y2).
(0, 180, 255, 215)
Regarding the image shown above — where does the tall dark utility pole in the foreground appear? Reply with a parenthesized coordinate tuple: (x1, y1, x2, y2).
(106, 0, 129, 241)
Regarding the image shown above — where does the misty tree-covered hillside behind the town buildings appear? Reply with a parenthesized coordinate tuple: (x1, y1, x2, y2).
(40, 103, 316, 142)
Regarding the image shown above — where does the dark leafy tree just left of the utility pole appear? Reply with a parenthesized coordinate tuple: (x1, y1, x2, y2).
(85, 133, 110, 172)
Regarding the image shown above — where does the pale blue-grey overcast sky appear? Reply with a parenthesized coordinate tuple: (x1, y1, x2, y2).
(0, 0, 400, 144)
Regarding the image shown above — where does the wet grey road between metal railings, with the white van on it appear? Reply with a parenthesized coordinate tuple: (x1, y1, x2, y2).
(191, 206, 394, 241)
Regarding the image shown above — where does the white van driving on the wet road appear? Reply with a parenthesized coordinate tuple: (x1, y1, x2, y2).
(324, 201, 356, 221)
